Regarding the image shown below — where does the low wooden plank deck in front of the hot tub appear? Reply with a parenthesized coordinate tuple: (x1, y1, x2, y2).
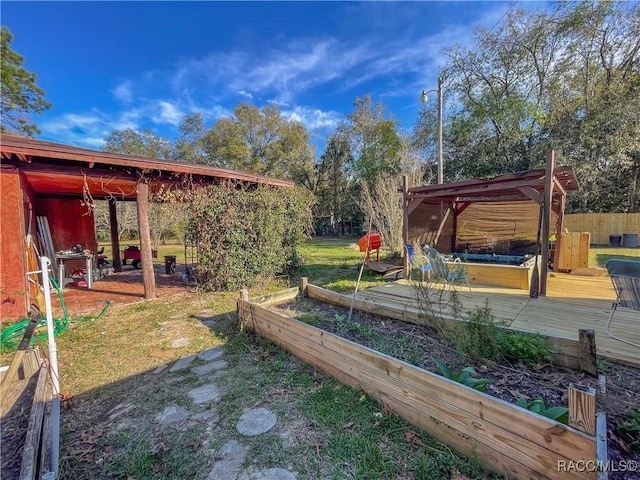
(358, 273, 640, 367)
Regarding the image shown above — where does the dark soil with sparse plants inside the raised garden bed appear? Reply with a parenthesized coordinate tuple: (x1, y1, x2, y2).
(273, 299, 640, 480)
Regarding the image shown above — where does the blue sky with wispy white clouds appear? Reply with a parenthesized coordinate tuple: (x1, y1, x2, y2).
(0, 0, 528, 153)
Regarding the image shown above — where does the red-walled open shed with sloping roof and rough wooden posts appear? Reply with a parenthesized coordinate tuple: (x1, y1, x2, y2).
(0, 134, 293, 318)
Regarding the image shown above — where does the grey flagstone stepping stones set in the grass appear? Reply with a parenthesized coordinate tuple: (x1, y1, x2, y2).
(156, 310, 297, 480)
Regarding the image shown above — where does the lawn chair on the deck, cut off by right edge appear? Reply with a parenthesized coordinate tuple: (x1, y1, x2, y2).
(606, 258, 640, 347)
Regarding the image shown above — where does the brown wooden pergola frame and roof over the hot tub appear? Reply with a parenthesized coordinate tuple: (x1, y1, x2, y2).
(402, 152, 579, 295)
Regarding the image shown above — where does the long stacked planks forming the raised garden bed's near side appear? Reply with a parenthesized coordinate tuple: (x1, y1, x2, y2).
(240, 300, 595, 478)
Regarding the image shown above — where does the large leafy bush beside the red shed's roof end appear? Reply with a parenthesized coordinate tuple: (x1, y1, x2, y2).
(187, 185, 312, 290)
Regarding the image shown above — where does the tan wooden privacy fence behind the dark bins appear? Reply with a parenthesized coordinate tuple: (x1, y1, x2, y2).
(564, 213, 640, 245)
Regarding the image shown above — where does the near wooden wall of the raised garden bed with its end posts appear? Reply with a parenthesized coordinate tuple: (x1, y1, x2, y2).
(238, 279, 606, 480)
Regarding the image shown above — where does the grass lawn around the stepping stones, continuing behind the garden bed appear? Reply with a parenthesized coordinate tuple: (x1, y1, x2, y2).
(30, 239, 494, 480)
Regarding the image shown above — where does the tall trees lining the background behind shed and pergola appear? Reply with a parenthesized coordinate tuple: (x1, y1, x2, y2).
(2, 1, 640, 251)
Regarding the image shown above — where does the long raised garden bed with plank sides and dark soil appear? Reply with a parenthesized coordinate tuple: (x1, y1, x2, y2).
(238, 285, 640, 479)
